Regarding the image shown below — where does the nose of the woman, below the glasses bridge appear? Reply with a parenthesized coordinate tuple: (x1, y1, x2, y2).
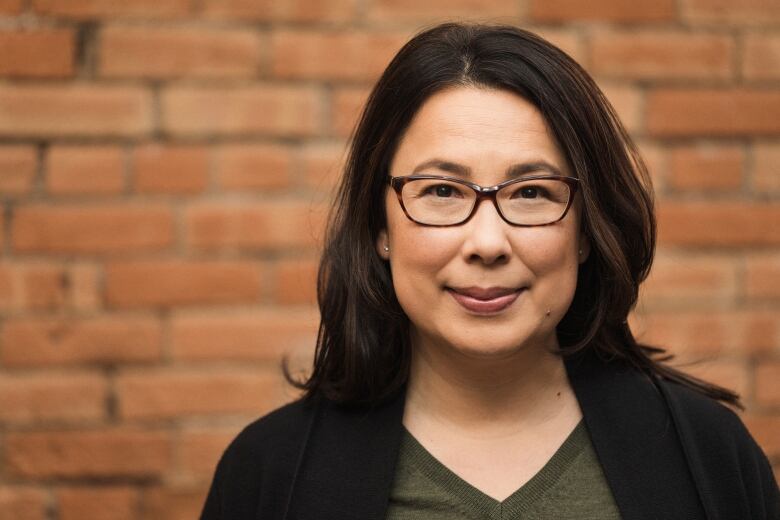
(463, 200, 511, 265)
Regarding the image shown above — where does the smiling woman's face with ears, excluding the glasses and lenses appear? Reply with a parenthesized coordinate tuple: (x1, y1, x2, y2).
(376, 87, 588, 357)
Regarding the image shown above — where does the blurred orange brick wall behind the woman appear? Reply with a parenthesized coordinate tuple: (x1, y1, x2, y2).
(0, 0, 780, 520)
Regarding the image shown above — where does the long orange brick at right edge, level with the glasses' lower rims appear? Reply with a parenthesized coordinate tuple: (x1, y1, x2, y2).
(658, 201, 780, 247)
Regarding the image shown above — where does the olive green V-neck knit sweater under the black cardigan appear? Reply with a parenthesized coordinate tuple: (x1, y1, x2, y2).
(387, 421, 620, 520)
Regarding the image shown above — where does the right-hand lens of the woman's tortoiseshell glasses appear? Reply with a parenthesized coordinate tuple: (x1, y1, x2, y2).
(496, 179, 571, 226)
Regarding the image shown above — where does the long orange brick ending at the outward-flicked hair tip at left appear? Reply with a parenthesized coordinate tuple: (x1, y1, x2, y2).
(116, 368, 282, 420)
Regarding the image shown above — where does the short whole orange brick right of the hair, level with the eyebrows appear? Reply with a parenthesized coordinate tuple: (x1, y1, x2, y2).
(667, 145, 745, 193)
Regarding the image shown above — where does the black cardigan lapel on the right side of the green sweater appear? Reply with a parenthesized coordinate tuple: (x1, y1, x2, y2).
(566, 354, 705, 520)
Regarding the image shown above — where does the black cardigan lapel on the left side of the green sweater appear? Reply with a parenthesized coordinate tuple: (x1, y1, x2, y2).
(286, 388, 406, 520)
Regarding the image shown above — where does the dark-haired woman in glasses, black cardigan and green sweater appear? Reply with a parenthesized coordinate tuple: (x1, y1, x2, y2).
(202, 24, 779, 519)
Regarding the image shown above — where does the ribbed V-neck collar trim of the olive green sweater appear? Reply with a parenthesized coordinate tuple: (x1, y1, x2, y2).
(401, 421, 589, 520)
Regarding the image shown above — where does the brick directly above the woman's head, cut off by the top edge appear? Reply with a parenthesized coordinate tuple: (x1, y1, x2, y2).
(368, 0, 521, 22)
